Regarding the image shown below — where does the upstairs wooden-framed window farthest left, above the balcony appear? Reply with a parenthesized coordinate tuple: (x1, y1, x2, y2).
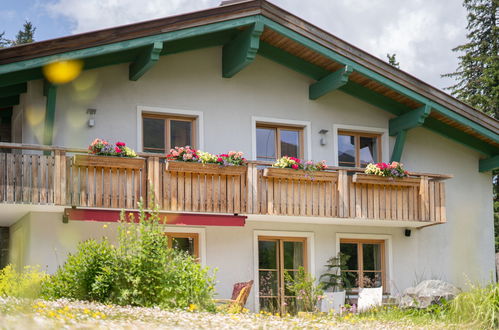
(142, 114, 195, 153)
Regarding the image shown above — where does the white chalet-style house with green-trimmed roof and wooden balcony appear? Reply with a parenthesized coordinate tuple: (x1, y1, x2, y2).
(0, 0, 499, 310)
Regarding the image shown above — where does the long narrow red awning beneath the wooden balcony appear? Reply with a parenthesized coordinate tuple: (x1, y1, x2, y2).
(64, 208, 246, 227)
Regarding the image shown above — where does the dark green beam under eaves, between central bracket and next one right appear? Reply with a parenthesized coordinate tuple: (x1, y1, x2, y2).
(258, 40, 331, 80)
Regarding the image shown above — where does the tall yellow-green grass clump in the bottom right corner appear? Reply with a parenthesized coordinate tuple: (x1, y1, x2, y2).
(448, 283, 499, 329)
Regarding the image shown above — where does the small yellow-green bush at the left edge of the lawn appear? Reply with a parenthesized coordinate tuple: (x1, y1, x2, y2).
(0, 265, 48, 299)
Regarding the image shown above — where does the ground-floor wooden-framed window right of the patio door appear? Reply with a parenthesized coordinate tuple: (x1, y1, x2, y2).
(340, 239, 387, 290)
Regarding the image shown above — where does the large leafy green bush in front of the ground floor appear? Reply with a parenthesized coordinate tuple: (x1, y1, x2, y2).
(44, 200, 215, 310)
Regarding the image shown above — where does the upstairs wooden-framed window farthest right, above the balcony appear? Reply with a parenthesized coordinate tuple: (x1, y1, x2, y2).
(338, 131, 381, 167)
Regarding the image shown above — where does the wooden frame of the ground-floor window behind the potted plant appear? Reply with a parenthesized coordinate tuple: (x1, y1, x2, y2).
(338, 238, 388, 293)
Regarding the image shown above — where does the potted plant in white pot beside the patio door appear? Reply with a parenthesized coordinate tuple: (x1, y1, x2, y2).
(319, 252, 355, 312)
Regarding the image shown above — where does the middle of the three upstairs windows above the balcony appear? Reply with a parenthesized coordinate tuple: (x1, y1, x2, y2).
(256, 124, 303, 161)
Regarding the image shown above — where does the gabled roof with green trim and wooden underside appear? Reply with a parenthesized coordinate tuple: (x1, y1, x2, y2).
(0, 0, 499, 165)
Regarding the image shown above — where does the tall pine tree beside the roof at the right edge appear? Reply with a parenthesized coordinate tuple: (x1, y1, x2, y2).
(442, 0, 499, 119)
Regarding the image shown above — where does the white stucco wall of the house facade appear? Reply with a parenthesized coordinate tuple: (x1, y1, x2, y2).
(13, 48, 494, 297)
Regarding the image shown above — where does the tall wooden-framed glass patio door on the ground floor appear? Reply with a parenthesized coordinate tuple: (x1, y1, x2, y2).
(258, 236, 307, 314)
